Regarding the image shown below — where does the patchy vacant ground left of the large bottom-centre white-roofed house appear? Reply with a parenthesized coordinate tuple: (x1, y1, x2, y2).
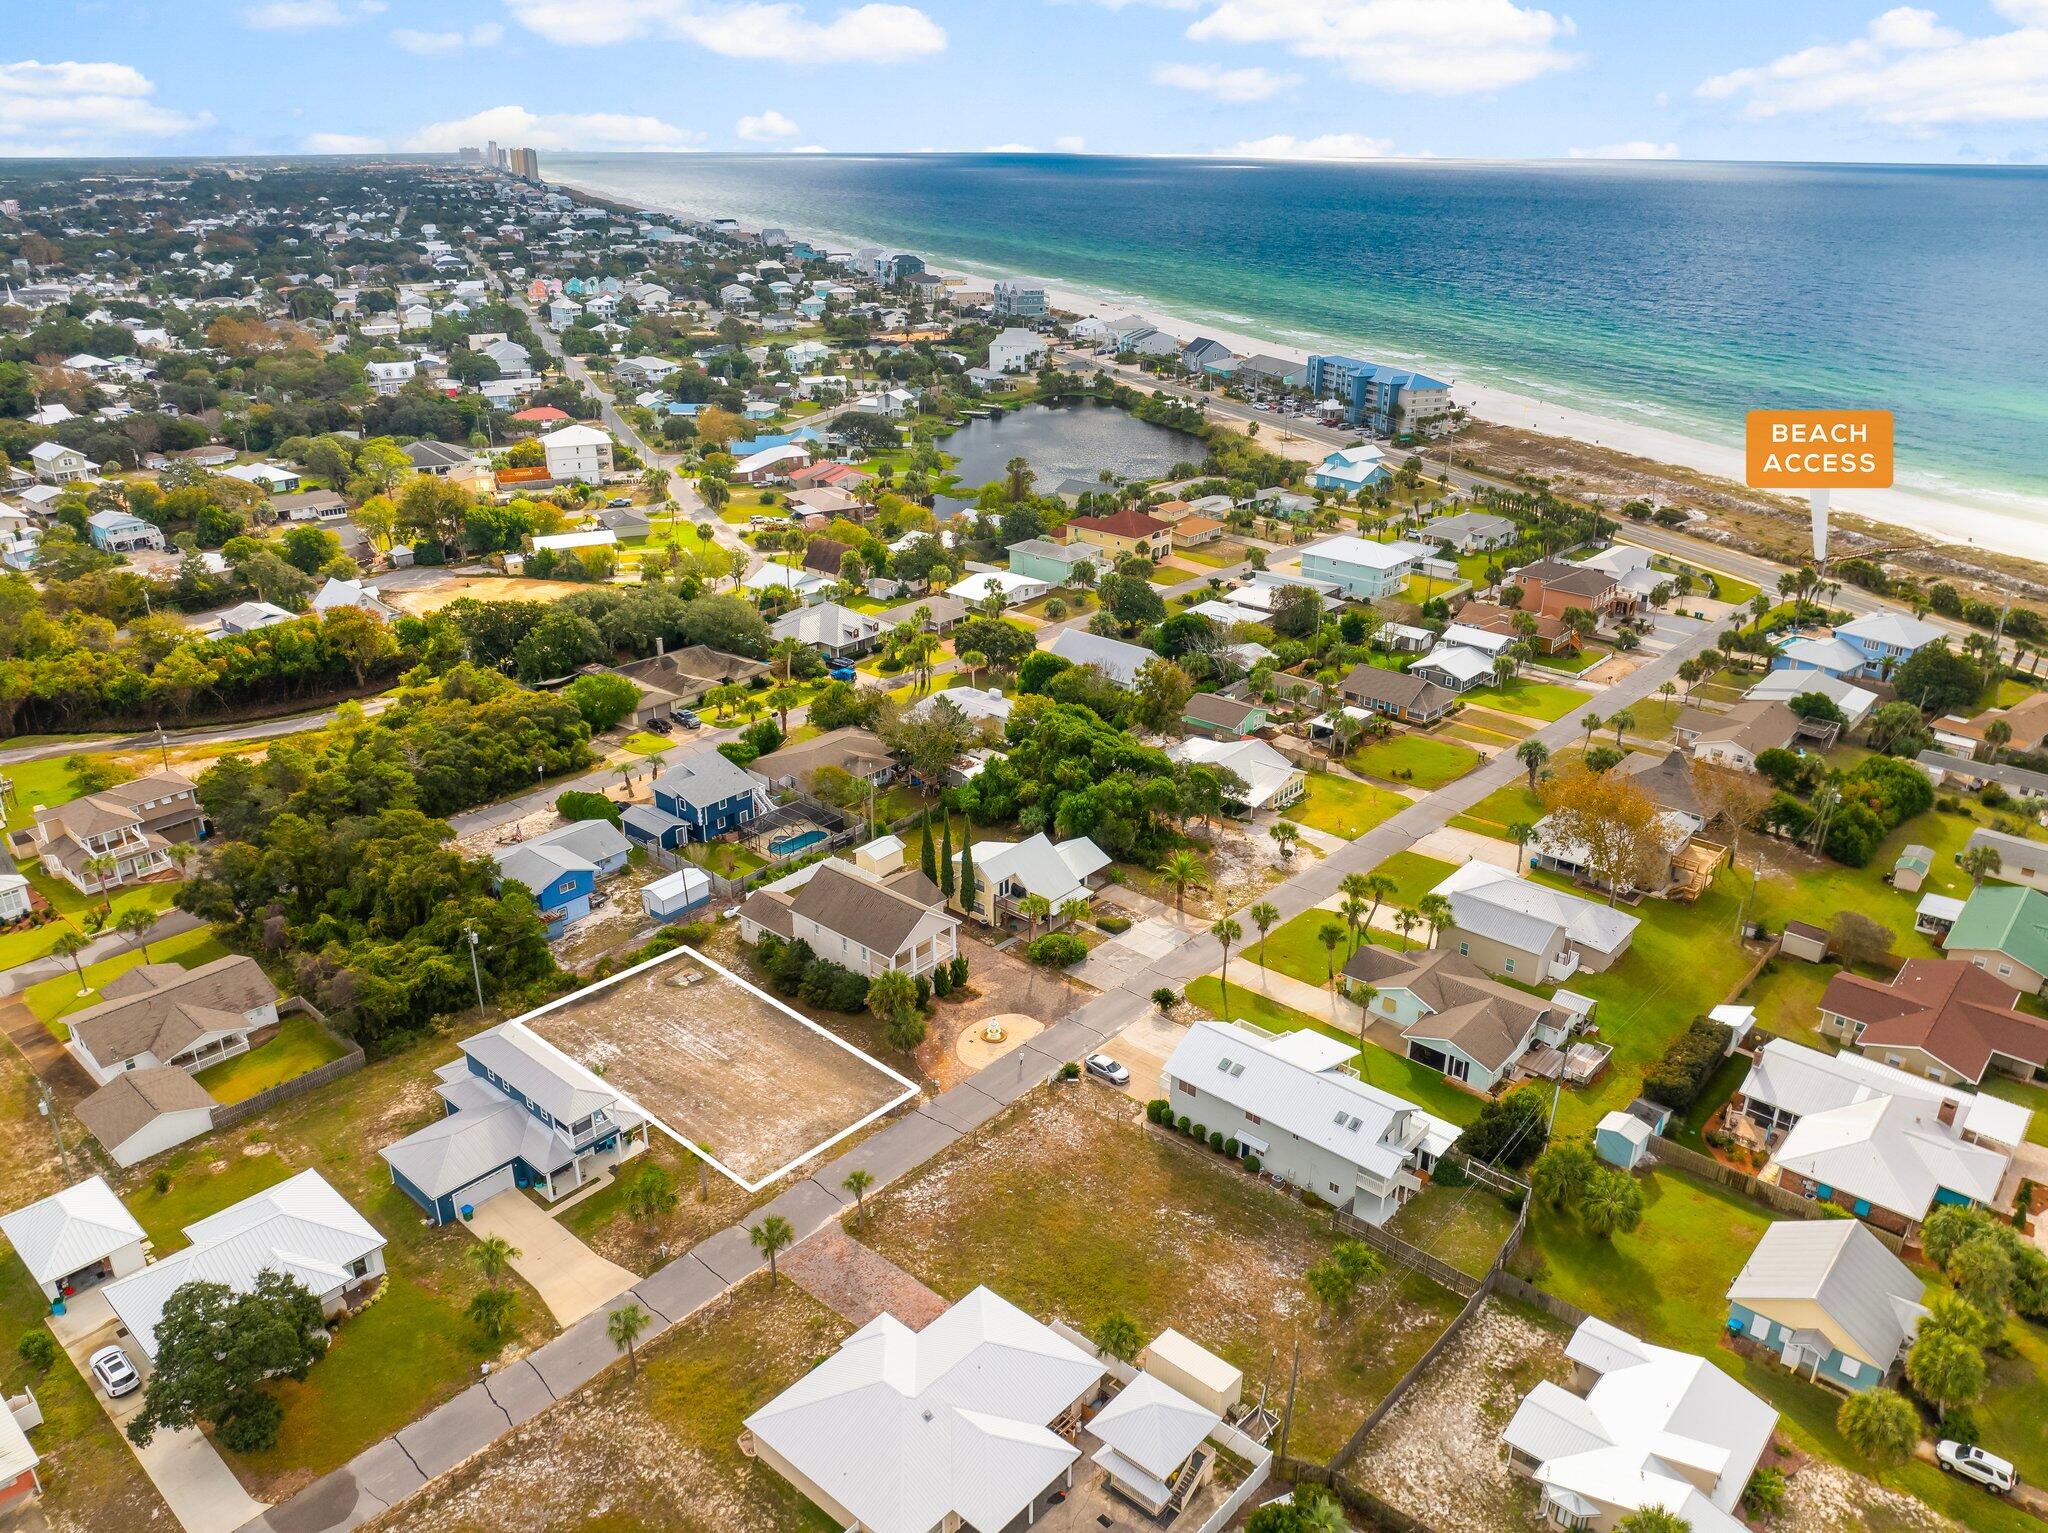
(373, 1277, 850, 1533)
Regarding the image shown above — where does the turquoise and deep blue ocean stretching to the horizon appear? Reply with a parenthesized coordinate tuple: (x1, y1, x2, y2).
(541, 154, 2048, 555)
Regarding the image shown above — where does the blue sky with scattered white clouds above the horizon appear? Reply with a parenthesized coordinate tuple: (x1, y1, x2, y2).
(0, 0, 2048, 164)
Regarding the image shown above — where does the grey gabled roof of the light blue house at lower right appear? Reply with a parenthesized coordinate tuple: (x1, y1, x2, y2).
(1729, 1220, 1925, 1367)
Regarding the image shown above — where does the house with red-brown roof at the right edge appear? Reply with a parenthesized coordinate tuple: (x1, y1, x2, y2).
(1821, 958, 2048, 1087)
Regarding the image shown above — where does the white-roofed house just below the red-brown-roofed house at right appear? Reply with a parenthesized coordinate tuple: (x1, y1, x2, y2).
(1726, 1038, 2032, 1234)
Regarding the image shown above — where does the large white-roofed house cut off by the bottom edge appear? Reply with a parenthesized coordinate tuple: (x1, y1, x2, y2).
(739, 1287, 1104, 1533)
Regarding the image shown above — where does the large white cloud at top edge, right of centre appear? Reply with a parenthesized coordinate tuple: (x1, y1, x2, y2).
(1188, 0, 1577, 96)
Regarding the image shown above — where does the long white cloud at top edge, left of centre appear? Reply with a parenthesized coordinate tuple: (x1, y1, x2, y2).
(506, 0, 946, 63)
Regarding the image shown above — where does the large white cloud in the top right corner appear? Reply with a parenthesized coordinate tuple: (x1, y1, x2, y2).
(1698, 0, 2048, 131)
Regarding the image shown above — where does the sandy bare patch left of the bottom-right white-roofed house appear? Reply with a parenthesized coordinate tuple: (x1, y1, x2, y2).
(1350, 1302, 1571, 1533)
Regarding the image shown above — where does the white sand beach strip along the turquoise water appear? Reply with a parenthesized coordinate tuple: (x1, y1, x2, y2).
(549, 168, 2048, 561)
